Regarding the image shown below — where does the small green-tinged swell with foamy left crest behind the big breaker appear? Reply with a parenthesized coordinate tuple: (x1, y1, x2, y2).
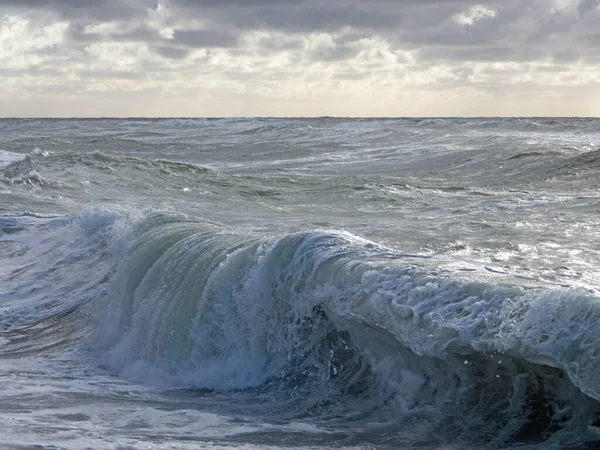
(0, 151, 304, 207)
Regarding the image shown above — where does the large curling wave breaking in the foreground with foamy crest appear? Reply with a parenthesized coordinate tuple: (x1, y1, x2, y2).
(82, 215, 600, 445)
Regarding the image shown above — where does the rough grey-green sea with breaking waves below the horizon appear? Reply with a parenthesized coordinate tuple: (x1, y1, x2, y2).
(0, 118, 600, 450)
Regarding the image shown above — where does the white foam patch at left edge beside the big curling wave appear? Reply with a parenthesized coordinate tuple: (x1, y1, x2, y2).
(0, 210, 129, 329)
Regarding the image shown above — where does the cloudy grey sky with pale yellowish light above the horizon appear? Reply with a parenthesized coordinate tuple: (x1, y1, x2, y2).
(0, 0, 600, 117)
